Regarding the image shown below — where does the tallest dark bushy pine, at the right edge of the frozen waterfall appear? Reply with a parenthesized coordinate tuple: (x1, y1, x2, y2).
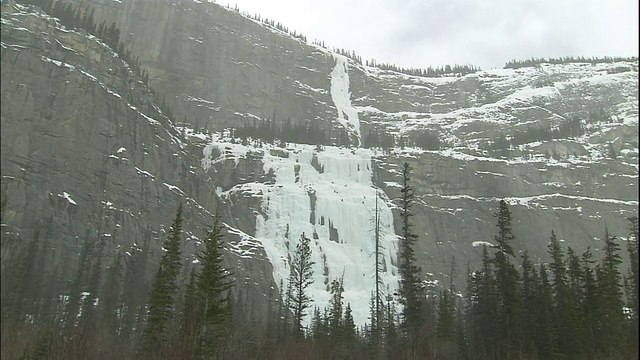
(398, 162, 424, 351)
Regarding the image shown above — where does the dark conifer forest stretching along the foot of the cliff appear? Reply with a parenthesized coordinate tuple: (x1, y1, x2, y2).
(2, 164, 638, 359)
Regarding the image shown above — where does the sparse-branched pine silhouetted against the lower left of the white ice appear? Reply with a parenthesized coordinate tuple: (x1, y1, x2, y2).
(287, 233, 315, 337)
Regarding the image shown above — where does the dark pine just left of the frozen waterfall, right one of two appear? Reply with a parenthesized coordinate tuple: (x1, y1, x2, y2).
(197, 216, 232, 356)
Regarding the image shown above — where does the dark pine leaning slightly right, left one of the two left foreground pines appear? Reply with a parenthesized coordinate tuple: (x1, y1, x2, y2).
(142, 204, 182, 355)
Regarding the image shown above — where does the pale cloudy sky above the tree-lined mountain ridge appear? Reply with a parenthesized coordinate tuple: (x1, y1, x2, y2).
(228, 0, 639, 69)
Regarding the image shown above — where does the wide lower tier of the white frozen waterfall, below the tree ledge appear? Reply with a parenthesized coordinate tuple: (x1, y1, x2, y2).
(203, 140, 398, 326)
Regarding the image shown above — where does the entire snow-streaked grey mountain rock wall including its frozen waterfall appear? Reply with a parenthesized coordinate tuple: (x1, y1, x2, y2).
(1, 0, 638, 324)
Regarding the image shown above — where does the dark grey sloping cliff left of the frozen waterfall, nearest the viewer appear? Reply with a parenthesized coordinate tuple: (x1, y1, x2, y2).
(1, 5, 273, 318)
